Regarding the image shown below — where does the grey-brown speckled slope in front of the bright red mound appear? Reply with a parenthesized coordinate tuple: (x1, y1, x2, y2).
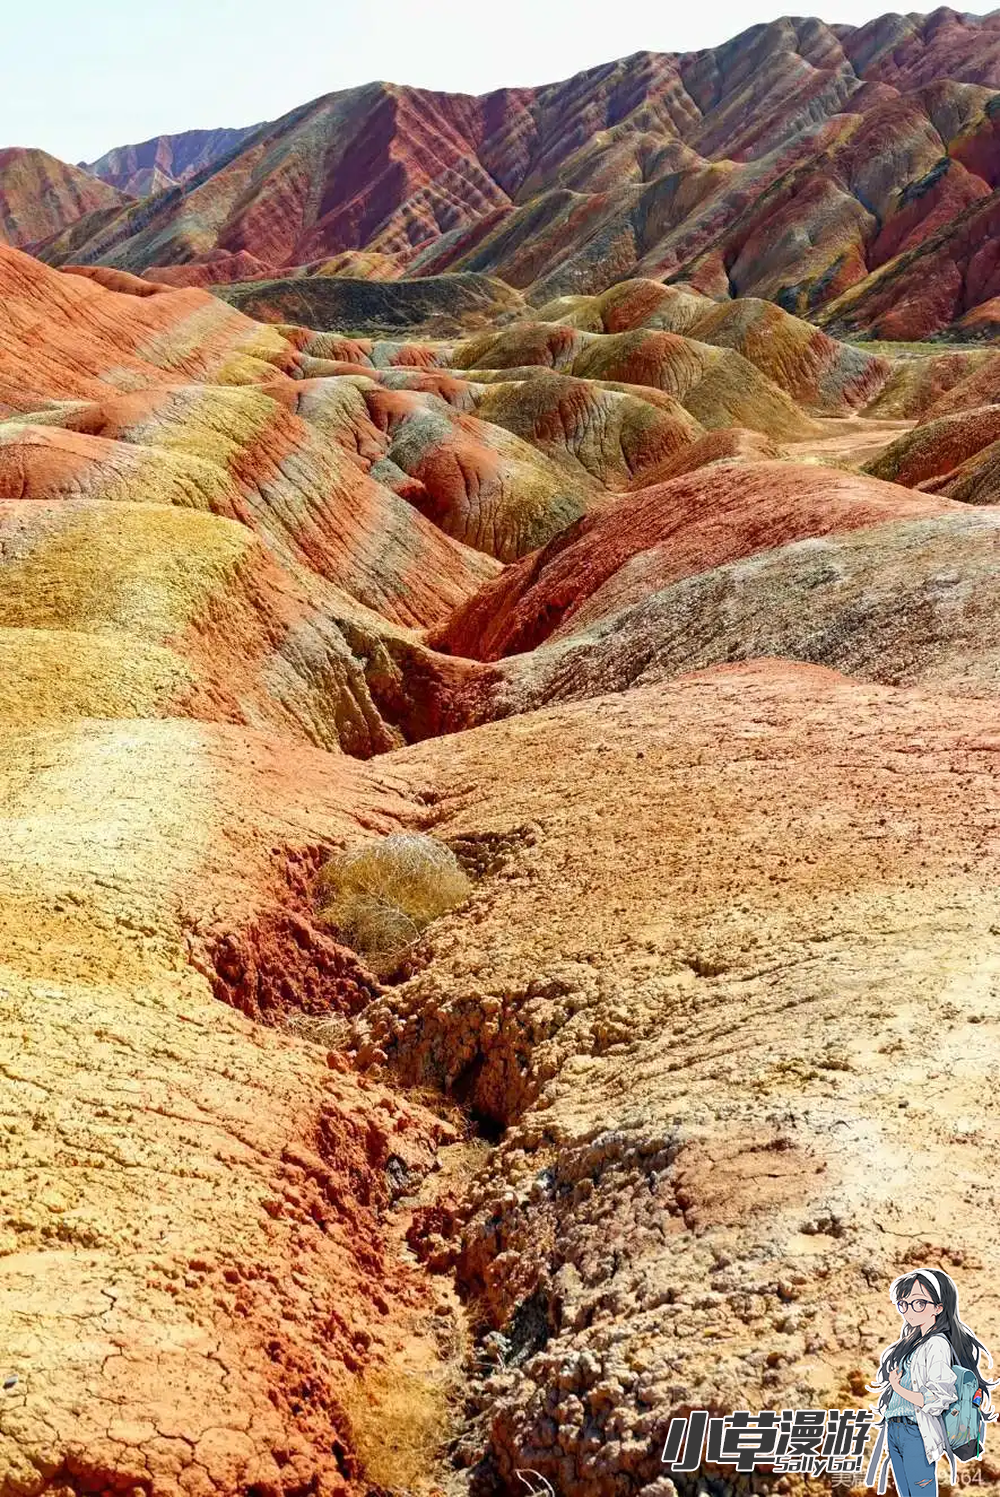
(457, 512, 1000, 725)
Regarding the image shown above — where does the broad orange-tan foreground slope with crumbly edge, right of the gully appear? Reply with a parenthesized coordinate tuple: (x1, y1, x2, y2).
(355, 663, 1000, 1497)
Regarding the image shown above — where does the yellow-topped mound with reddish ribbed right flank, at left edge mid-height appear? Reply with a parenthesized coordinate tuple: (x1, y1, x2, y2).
(0, 485, 463, 759)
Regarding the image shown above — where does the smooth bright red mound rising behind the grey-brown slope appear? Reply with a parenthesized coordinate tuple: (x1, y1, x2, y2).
(433, 463, 946, 660)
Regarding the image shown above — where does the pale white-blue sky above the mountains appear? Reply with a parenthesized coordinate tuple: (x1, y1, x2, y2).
(0, 0, 982, 162)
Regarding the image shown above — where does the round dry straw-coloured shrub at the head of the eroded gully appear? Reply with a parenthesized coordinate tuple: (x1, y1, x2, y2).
(319, 832, 472, 958)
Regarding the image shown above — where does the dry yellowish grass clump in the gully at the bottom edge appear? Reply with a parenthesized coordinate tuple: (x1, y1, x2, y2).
(338, 1367, 455, 1493)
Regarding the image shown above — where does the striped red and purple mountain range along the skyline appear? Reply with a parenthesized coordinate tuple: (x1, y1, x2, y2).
(11, 9, 1000, 337)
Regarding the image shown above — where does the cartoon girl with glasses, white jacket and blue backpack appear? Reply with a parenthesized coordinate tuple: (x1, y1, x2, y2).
(868, 1268, 997, 1497)
